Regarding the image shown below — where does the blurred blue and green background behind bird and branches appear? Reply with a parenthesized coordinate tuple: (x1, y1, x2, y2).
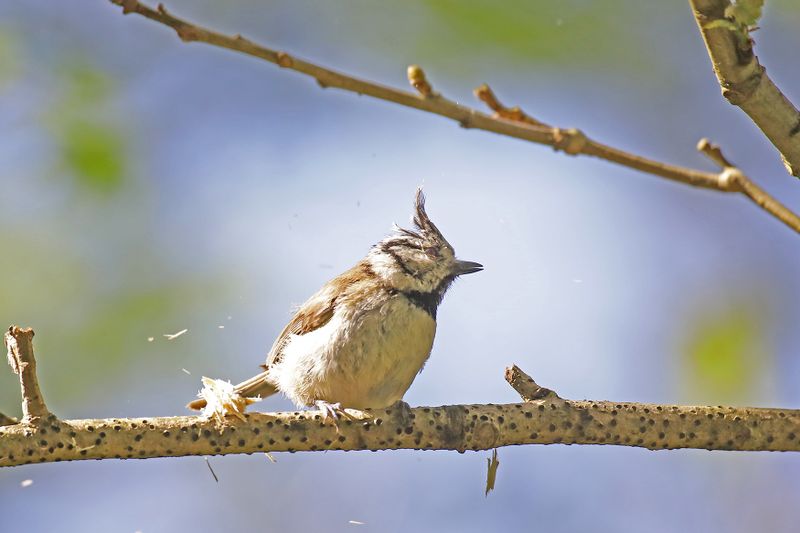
(0, 0, 800, 533)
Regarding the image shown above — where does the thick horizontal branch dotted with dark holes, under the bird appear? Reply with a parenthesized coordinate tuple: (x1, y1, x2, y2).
(0, 328, 800, 466)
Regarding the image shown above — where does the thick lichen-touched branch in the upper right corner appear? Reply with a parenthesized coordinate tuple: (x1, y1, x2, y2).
(689, 0, 800, 178)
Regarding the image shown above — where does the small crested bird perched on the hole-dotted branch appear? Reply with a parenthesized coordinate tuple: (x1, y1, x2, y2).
(187, 188, 483, 418)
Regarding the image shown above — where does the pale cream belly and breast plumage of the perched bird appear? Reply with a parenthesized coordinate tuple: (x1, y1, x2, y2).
(270, 295, 436, 409)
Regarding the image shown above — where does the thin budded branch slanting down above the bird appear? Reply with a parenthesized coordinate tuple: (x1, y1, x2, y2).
(110, 0, 800, 233)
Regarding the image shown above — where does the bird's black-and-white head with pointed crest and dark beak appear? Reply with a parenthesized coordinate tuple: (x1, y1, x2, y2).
(368, 189, 483, 298)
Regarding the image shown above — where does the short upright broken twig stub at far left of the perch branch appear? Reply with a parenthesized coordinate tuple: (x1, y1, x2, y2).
(5, 326, 50, 424)
